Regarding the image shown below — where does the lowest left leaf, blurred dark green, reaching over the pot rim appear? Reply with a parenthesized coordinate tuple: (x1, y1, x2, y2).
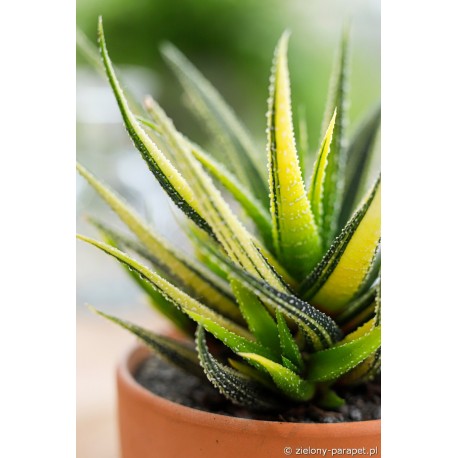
(89, 307, 204, 378)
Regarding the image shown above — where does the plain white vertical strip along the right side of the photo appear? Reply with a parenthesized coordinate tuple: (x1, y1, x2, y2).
(382, 0, 458, 458)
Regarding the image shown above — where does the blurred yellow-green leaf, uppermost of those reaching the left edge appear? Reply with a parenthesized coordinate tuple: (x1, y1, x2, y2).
(77, 164, 240, 319)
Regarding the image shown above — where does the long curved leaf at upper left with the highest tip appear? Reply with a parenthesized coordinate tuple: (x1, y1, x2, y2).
(99, 18, 211, 233)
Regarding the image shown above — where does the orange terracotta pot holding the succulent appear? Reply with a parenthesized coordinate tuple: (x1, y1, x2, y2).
(117, 346, 380, 458)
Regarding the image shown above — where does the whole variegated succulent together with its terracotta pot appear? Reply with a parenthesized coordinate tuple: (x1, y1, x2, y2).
(78, 20, 381, 458)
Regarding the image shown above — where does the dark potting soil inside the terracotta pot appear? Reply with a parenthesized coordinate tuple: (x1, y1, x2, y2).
(135, 355, 380, 423)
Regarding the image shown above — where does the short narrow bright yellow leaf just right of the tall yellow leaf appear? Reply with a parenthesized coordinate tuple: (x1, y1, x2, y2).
(308, 111, 337, 231)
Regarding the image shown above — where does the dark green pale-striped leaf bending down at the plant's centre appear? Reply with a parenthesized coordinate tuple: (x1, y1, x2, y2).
(199, 247, 341, 350)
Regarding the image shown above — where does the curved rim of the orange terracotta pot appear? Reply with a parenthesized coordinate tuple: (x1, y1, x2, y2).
(116, 344, 381, 436)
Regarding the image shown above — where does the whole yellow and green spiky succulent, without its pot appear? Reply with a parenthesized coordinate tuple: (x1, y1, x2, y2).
(78, 21, 381, 411)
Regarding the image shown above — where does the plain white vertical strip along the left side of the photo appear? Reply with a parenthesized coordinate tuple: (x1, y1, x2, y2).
(0, 0, 75, 458)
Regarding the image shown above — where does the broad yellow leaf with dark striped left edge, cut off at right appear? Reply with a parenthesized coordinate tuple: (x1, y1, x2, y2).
(301, 178, 381, 315)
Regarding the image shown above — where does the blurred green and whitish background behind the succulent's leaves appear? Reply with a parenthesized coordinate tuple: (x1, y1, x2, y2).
(76, 0, 380, 306)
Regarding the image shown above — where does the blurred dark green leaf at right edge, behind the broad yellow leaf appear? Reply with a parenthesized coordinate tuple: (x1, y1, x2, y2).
(338, 105, 381, 227)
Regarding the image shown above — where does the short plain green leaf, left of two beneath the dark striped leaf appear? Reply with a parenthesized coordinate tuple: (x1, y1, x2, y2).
(230, 278, 280, 354)
